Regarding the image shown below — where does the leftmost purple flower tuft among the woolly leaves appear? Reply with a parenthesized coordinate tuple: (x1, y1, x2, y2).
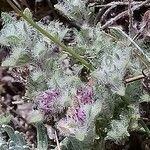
(36, 89, 60, 114)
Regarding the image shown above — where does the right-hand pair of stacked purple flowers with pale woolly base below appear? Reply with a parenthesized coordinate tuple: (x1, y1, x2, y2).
(57, 86, 94, 137)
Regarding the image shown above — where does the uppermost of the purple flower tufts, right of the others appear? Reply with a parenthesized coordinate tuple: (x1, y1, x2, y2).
(76, 86, 93, 105)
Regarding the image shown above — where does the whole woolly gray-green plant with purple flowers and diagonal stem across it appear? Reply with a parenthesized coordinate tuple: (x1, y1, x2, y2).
(0, 0, 149, 150)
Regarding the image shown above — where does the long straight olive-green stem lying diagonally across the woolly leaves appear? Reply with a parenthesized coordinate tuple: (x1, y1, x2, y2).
(7, 0, 94, 70)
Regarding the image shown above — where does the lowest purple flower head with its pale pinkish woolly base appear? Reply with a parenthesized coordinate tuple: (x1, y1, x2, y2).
(57, 105, 91, 136)
